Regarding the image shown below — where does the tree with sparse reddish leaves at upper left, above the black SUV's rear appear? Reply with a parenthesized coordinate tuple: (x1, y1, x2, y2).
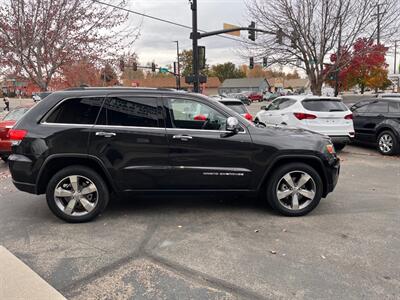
(0, 0, 138, 90)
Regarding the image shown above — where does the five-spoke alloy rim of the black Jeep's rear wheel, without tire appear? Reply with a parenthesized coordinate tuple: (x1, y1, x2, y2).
(54, 175, 99, 217)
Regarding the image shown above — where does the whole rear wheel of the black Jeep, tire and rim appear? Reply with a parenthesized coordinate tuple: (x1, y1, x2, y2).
(46, 166, 110, 223)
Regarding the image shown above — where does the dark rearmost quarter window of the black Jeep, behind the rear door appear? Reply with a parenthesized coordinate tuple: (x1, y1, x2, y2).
(46, 98, 103, 125)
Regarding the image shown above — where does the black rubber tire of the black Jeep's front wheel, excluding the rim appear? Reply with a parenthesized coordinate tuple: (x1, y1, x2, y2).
(266, 163, 323, 217)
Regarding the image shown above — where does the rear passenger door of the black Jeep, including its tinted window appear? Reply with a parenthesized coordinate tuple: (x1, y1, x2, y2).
(89, 93, 168, 192)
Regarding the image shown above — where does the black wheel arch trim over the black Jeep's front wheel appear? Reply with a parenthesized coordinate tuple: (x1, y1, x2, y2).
(258, 155, 328, 197)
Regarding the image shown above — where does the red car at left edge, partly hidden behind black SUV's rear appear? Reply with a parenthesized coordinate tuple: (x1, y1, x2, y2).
(0, 107, 30, 161)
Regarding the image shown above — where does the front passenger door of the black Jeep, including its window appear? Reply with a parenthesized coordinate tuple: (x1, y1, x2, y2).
(164, 97, 253, 190)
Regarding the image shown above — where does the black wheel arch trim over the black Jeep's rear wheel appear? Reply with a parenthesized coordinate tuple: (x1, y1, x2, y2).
(36, 154, 118, 194)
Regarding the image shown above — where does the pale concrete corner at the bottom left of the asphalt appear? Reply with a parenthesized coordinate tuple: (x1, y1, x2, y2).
(0, 246, 66, 300)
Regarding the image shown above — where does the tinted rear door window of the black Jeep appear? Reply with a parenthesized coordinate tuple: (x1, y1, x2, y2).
(97, 97, 159, 127)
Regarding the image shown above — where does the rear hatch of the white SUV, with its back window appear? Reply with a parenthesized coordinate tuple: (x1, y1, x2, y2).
(301, 98, 354, 136)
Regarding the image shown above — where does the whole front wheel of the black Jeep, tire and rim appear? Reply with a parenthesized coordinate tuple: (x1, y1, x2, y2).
(267, 163, 323, 217)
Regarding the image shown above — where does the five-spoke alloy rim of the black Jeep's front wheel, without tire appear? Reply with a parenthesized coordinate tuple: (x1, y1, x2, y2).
(276, 171, 316, 210)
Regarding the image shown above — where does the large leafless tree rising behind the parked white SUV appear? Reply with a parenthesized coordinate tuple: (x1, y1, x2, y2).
(244, 0, 400, 95)
